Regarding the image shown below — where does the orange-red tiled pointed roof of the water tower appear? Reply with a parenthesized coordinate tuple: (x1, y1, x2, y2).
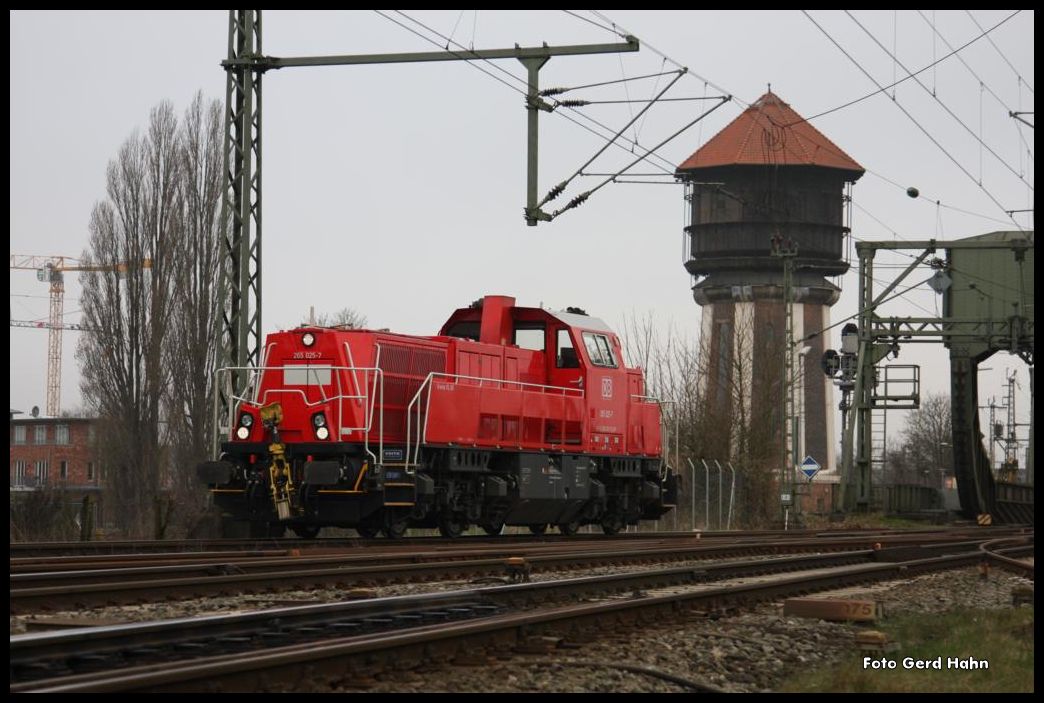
(678, 92, 863, 180)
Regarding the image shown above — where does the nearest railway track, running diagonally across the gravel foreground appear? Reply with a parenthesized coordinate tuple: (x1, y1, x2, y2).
(11, 540, 1033, 693)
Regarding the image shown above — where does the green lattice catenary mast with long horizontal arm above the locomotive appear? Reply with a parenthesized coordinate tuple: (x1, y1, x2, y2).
(216, 9, 639, 431)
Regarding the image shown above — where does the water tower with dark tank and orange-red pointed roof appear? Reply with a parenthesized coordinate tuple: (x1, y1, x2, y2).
(677, 92, 863, 499)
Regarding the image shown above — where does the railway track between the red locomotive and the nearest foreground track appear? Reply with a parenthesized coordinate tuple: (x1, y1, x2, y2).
(9, 533, 1018, 614)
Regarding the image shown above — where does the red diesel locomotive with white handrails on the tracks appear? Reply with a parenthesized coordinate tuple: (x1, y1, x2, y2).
(198, 296, 677, 537)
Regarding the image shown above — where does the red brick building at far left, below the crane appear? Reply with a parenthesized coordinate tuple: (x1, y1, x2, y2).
(10, 411, 101, 501)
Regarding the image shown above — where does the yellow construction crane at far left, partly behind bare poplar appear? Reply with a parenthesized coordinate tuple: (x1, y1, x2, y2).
(10, 254, 152, 417)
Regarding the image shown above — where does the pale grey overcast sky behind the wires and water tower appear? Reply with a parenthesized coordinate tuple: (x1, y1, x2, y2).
(10, 10, 1036, 465)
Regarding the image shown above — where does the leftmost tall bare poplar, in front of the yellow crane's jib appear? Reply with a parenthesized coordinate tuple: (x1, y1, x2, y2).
(77, 102, 184, 535)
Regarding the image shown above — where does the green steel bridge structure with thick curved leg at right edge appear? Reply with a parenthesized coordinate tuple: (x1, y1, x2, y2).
(841, 231, 1034, 519)
